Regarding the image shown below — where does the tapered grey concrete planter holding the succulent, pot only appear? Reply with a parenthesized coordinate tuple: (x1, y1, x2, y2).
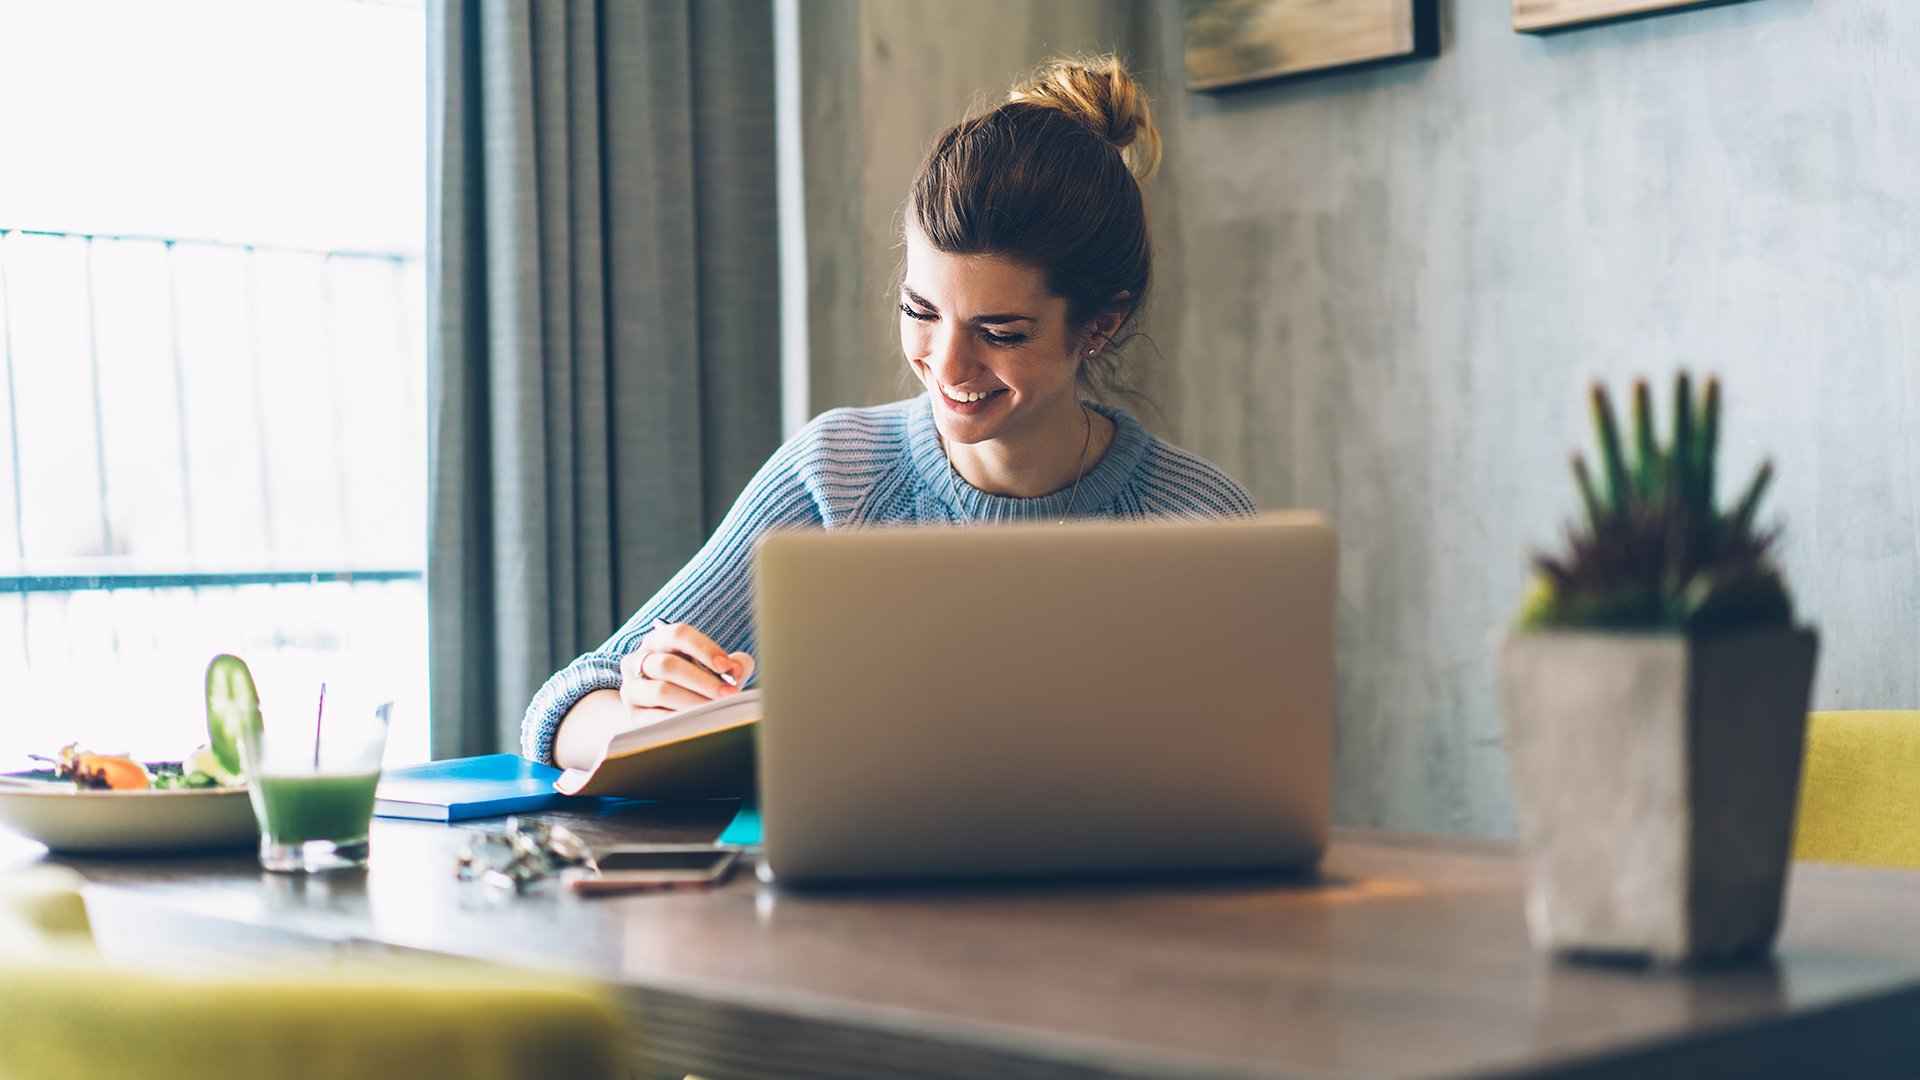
(1500, 628, 1818, 965)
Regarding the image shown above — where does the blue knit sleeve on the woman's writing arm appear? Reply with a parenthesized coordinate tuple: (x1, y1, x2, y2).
(520, 430, 826, 765)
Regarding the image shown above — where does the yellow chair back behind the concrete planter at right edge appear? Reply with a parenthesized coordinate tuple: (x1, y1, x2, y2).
(1793, 711, 1920, 869)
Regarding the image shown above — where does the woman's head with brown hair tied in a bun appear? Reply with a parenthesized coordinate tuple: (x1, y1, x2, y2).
(900, 56, 1160, 499)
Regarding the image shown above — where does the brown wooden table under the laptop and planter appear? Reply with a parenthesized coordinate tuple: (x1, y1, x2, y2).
(15, 803, 1920, 1080)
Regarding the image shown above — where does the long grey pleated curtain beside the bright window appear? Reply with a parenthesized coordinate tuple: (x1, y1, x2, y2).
(426, 0, 780, 757)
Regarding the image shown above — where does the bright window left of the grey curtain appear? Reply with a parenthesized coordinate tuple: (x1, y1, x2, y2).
(0, 0, 426, 767)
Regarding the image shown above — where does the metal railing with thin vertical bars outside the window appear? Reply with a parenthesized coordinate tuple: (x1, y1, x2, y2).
(0, 227, 426, 763)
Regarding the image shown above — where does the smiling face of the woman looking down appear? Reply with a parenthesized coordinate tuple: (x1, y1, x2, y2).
(900, 227, 1087, 444)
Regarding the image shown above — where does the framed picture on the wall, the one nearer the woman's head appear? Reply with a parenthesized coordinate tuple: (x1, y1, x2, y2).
(1185, 0, 1440, 90)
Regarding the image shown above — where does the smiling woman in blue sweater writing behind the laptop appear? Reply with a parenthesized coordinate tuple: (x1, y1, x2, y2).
(520, 58, 1254, 767)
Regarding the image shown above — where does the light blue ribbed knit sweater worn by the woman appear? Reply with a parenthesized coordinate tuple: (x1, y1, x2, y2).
(520, 394, 1254, 763)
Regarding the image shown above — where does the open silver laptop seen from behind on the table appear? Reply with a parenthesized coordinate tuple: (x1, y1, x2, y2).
(756, 513, 1334, 884)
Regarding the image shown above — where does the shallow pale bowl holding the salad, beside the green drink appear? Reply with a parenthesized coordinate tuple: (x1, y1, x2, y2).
(0, 773, 259, 853)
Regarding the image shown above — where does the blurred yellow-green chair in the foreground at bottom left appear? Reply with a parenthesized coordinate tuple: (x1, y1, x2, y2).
(0, 867, 632, 1080)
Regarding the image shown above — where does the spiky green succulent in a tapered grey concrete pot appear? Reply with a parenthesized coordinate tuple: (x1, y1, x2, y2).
(1500, 375, 1818, 965)
